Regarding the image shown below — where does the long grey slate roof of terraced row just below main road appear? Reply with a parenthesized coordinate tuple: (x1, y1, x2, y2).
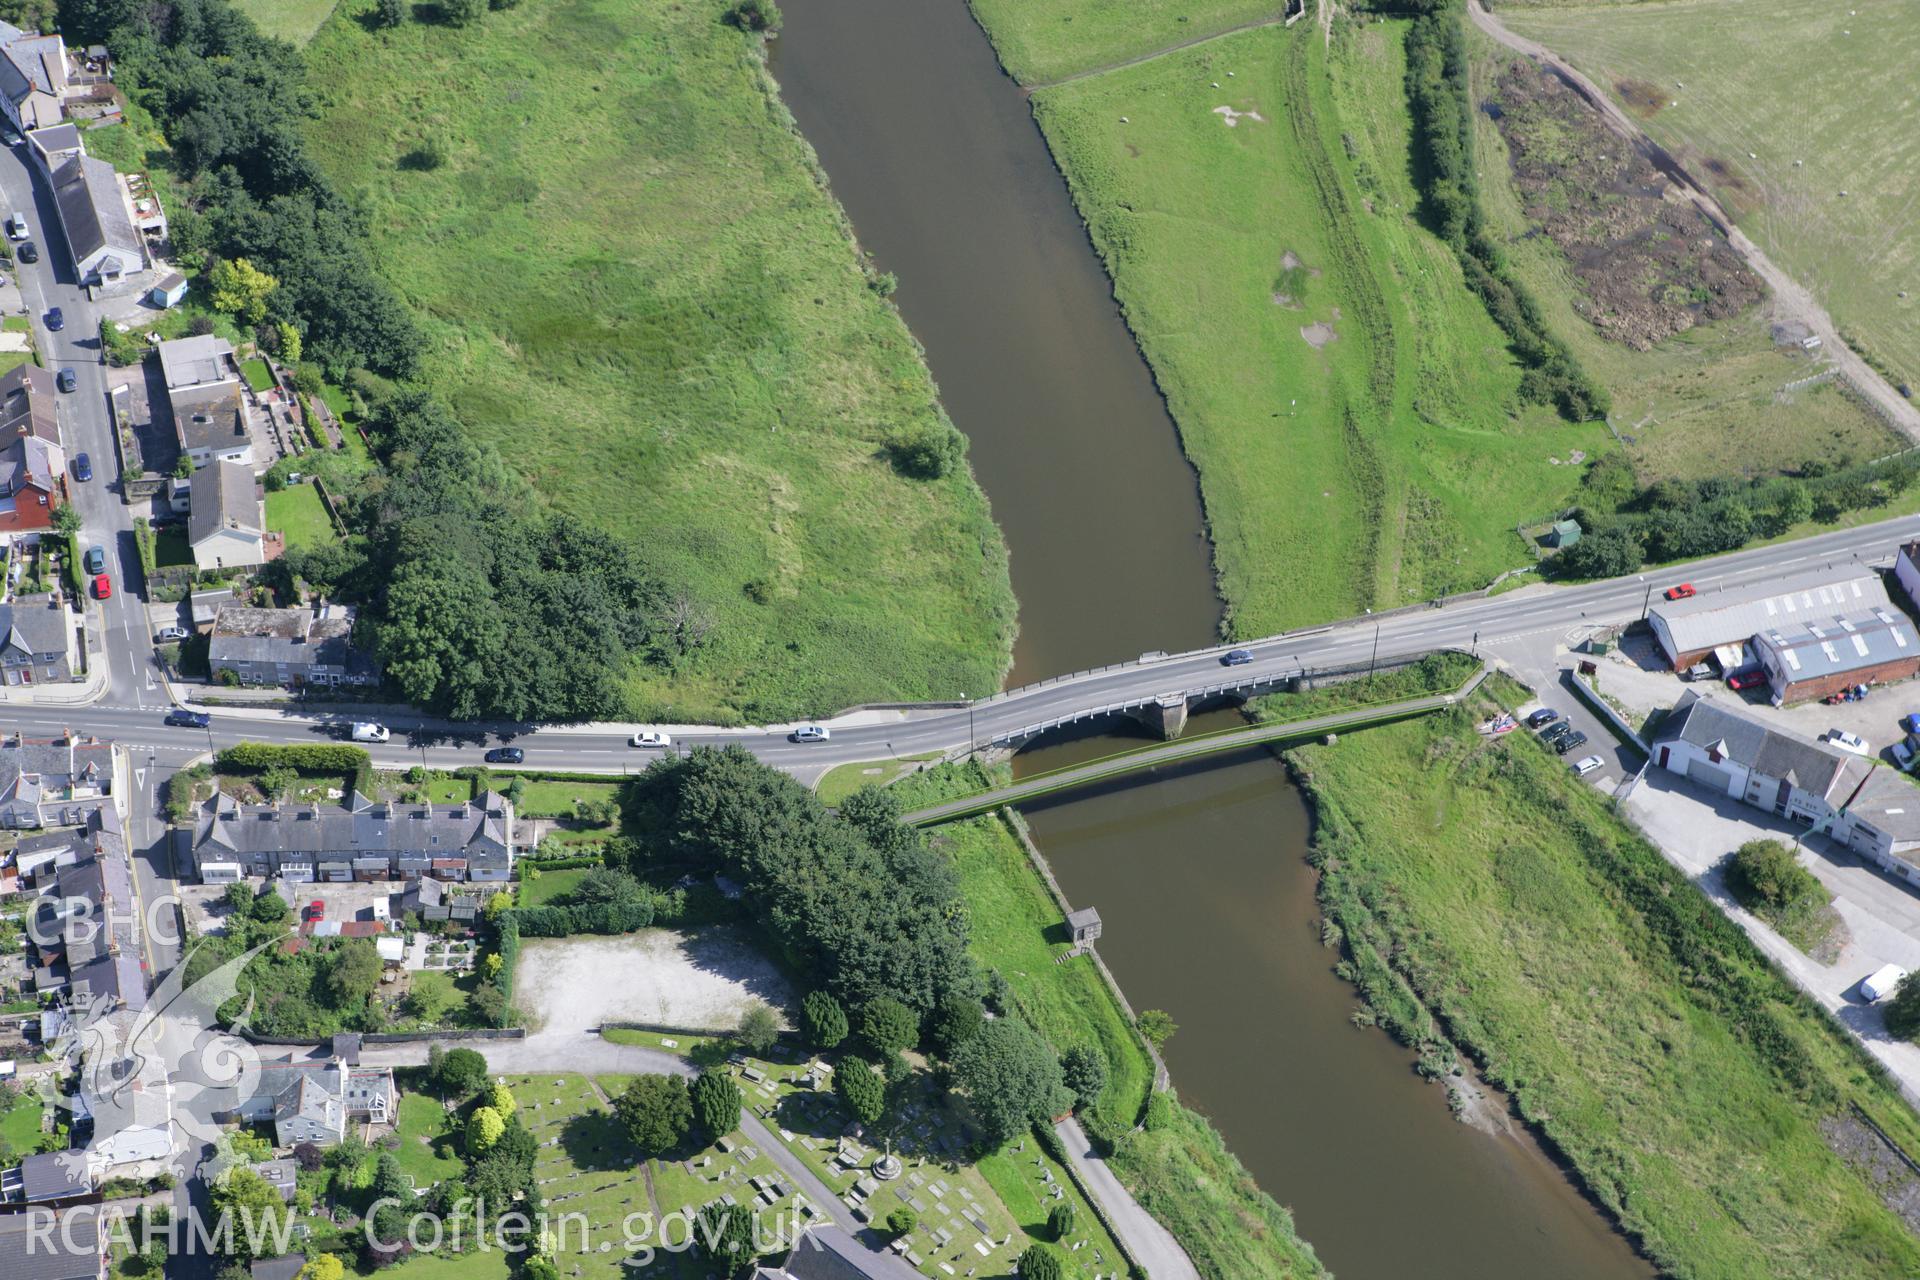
(194, 791, 513, 860)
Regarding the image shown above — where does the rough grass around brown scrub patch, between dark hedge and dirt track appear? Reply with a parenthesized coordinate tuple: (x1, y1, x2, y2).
(1469, 35, 1905, 484)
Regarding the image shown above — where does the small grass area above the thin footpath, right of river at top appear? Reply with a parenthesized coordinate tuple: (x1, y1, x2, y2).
(972, 0, 1284, 84)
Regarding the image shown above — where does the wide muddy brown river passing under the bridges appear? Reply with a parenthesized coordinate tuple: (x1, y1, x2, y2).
(774, 0, 1649, 1280)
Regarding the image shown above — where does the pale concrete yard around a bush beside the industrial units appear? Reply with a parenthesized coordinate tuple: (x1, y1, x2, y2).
(1626, 770, 1920, 1105)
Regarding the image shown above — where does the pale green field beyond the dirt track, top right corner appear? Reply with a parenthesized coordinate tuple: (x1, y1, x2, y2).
(1501, 0, 1920, 395)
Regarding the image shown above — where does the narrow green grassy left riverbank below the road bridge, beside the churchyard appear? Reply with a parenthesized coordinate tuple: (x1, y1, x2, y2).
(889, 764, 1323, 1280)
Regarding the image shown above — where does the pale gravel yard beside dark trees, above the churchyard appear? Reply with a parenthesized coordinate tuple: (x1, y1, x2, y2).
(515, 929, 793, 1032)
